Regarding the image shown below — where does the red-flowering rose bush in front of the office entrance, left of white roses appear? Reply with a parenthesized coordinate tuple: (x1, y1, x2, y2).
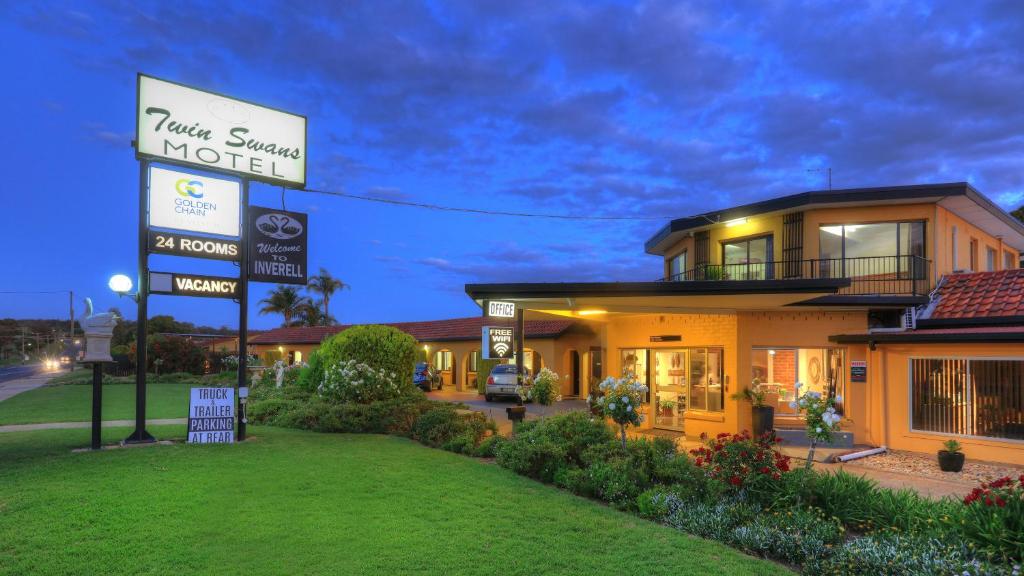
(690, 430, 790, 494)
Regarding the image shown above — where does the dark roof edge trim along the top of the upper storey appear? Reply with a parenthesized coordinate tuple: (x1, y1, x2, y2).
(644, 182, 1024, 254)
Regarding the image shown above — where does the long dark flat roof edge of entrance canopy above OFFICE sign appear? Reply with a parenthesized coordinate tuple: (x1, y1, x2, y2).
(466, 278, 850, 299)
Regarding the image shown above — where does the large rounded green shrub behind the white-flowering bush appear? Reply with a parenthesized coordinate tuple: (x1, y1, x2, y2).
(319, 325, 416, 387)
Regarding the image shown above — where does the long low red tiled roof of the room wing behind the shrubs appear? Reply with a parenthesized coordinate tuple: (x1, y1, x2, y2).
(249, 317, 575, 344)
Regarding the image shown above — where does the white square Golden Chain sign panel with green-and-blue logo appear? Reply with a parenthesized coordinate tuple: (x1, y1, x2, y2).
(150, 166, 242, 238)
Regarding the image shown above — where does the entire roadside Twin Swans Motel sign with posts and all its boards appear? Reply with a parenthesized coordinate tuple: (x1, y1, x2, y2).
(126, 74, 307, 444)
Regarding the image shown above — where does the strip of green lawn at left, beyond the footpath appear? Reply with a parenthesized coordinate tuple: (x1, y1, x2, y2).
(0, 383, 198, 425)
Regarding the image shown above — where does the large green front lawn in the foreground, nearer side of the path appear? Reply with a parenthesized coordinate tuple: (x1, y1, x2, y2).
(0, 426, 787, 576)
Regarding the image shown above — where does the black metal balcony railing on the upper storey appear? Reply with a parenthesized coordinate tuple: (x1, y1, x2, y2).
(665, 256, 931, 296)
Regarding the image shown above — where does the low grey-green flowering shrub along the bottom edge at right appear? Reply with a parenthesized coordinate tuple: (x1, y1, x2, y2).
(804, 534, 1020, 576)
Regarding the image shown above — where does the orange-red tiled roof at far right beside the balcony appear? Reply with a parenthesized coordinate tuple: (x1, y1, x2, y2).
(929, 269, 1024, 320)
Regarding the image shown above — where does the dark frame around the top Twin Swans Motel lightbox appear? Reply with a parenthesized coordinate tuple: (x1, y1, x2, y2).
(133, 72, 309, 190)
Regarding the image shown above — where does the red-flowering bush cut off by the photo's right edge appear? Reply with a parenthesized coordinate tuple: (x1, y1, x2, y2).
(963, 475, 1024, 561)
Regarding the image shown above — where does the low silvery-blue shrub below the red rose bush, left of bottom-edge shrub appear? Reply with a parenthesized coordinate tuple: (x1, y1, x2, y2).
(731, 507, 845, 565)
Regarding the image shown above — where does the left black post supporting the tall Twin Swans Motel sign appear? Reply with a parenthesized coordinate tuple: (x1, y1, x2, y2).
(125, 160, 157, 444)
